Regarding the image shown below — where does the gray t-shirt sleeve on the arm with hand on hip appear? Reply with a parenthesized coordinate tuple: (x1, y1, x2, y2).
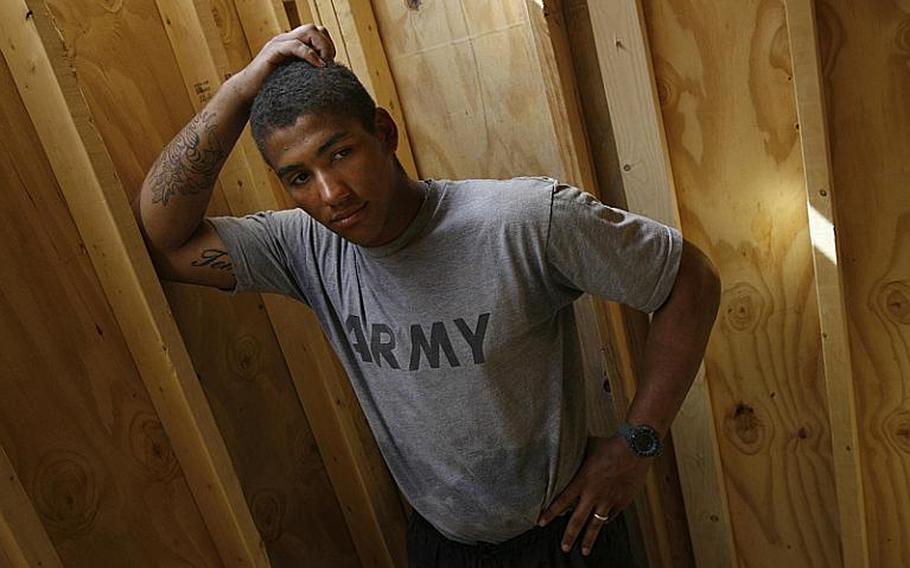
(547, 183, 683, 313)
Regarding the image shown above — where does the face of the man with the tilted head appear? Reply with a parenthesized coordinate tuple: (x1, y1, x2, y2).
(266, 110, 407, 246)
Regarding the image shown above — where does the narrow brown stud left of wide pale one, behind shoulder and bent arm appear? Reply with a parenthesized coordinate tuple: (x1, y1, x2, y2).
(525, 0, 692, 566)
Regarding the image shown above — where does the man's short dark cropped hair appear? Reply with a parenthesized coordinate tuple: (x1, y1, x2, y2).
(250, 59, 376, 156)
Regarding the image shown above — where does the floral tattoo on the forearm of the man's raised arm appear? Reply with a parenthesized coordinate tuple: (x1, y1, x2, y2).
(149, 110, 227, 206)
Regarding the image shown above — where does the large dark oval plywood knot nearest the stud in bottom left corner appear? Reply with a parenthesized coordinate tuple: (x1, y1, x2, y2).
(34, 451, 99, 538)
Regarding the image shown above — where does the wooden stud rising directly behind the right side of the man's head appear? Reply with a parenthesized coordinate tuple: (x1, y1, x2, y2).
(330, 0, 417, 176)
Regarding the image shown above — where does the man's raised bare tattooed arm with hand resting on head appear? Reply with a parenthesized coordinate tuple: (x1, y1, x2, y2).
(133, 24, 335, 288)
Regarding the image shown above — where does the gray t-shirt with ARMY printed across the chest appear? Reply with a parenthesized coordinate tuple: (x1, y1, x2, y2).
(210, 178, 682, 544)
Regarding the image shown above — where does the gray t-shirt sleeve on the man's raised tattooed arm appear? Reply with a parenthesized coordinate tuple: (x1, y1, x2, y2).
(206, 210, 309, 303)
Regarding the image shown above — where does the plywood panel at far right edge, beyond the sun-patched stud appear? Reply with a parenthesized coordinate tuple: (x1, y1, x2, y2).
(820, 0, 910, 567)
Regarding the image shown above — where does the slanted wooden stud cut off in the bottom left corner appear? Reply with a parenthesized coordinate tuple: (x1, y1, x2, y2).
(0, 445, 63, 568)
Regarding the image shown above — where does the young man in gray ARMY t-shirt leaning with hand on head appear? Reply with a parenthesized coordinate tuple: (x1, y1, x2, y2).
(137, 25, 719, 568)
